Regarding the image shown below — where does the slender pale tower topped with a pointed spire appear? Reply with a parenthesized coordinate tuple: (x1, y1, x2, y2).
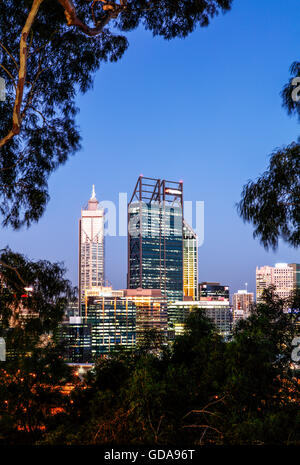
(79, 186, 104, 306)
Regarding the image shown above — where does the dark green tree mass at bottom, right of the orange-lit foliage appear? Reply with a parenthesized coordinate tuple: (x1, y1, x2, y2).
(35, 289, 300, 447)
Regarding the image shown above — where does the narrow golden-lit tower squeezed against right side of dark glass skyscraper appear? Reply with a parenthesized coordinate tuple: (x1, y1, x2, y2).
(183, 221, 198, 300)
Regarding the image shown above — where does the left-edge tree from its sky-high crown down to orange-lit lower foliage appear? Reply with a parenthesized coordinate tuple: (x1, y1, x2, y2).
(0, 249, 74, 444)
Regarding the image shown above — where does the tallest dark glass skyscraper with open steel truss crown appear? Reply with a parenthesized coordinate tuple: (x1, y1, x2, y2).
(127, 176, 183, 300)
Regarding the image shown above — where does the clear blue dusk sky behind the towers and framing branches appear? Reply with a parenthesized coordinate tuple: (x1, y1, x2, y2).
(0, 0, 300, 292)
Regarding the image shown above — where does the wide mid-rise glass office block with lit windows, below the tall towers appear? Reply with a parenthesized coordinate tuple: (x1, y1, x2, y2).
(76, 287, 168, 361)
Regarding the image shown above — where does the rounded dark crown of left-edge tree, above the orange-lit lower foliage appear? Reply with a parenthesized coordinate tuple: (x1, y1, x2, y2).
(0, 248, 74, 340)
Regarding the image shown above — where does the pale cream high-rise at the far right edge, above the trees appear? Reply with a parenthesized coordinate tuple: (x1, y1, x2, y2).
(256, 263, 300, 303)
